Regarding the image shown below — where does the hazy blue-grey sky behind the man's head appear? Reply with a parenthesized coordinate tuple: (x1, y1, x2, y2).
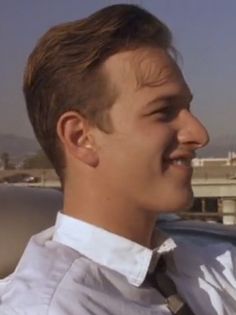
(0, 0, 236, 141)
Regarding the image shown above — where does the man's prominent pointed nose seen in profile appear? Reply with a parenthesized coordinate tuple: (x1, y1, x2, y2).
(178, 110, 209, 149)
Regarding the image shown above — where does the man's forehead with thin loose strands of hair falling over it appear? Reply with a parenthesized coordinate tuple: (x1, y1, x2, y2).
(103, 48, 185, 89)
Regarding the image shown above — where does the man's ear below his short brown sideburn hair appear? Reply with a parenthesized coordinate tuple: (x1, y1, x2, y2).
(57, 111, 99, 167)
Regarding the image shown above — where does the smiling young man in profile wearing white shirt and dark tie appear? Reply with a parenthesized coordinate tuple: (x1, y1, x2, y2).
(0, 5, 236, 315)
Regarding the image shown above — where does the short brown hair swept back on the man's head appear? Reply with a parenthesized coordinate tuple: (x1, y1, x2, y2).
(24, 4, 172, 180)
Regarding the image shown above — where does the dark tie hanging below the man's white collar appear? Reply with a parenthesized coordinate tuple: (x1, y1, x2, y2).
(147, 256, 194, 315)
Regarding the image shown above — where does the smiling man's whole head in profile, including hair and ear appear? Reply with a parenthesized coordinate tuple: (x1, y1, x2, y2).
(24, 5, 208, 217)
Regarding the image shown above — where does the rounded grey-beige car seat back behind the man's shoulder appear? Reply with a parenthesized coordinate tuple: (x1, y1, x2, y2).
(0, 184, 62, 278)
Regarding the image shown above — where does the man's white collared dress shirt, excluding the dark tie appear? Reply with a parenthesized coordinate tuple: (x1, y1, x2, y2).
(0, 213, 236, 315)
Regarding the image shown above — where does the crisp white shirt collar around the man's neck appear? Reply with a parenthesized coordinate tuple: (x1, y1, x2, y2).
(53, 212, 176, 287)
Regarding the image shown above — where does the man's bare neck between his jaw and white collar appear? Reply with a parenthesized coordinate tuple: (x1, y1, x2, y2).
(64, 185, 157, 248)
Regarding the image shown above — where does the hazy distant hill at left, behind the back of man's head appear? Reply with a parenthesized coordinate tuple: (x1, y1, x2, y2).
(0, 134, 39, 158)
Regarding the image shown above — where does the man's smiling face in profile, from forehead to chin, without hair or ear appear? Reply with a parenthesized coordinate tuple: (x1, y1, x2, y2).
(94, 48, 208, 212)
